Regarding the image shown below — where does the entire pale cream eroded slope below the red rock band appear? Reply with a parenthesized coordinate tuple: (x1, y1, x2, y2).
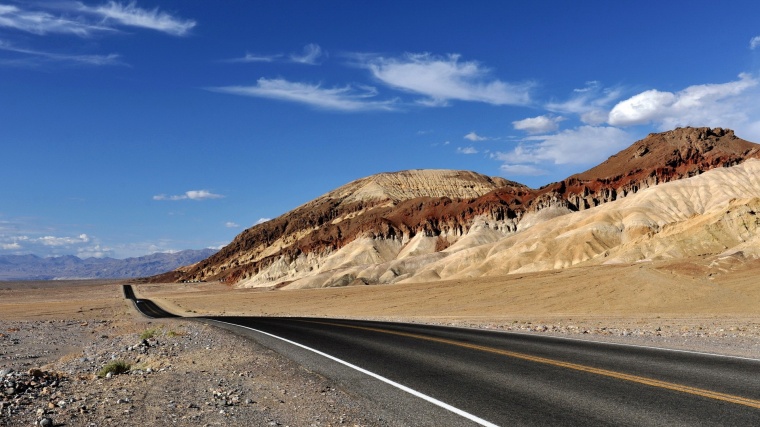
(286, 160, 760, 288)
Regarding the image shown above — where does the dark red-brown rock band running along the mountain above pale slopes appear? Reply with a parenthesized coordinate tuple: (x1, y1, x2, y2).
(150, 128, 760, 283)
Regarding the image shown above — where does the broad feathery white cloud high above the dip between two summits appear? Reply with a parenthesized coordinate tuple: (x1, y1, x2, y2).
(363, 53, 532, 106)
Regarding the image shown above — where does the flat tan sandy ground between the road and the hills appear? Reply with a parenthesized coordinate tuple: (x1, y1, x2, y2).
(136, 258, 760, 358)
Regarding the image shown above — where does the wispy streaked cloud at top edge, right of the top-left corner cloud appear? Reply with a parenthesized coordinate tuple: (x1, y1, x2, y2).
(84, 1, 196, 36)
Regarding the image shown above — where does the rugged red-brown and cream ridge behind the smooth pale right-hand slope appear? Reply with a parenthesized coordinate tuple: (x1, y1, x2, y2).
(153, 128, 760, 287)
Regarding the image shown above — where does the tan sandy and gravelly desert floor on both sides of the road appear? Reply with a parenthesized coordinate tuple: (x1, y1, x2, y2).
(0, 259, 760, 426)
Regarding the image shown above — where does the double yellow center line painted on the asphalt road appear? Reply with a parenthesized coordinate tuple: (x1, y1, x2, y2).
(304, 321, 760, 409)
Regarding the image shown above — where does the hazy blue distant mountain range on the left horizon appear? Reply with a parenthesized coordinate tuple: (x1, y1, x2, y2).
(0, 249, 216, 281)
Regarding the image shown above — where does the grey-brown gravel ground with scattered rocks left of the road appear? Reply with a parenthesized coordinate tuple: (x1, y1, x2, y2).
(0, 319, 392, 426)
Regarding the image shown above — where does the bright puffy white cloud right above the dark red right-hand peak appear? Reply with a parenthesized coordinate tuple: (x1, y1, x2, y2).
(608, 74, 759, 131)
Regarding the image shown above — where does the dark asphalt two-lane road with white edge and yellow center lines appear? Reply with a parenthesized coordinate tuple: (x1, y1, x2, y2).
(125, 290, 760, 426)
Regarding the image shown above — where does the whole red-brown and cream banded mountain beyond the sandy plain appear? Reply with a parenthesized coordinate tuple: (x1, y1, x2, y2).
(152, 128, 760, 288)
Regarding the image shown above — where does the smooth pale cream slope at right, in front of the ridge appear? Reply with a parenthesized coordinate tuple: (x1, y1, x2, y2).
(418, 160, 760, 280)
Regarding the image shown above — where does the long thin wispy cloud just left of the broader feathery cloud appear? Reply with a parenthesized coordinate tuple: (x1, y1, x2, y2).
(208, 78, 395, 111)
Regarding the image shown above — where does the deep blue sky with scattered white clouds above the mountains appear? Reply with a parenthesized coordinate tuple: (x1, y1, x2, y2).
(0, 0, 760, 258)
